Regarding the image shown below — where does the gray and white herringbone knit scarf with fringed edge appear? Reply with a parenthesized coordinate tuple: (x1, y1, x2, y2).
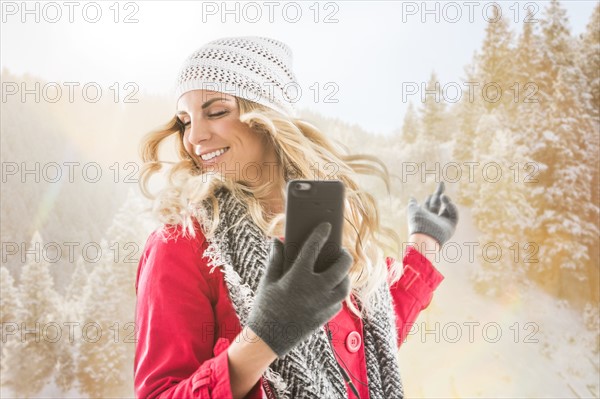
(199, 187, 404, 399)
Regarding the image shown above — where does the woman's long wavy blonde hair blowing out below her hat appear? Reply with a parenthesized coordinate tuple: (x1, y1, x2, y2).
(139, 97, 402, 318)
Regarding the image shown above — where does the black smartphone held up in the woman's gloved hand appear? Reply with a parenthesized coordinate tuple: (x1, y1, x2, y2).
(284, 180, 344, 273)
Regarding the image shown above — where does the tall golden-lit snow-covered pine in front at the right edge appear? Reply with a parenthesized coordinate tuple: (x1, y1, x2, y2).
(540, 68, 600, 298)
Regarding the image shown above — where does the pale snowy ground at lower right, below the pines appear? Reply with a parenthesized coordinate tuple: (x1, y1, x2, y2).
(400, 209, 600, 398)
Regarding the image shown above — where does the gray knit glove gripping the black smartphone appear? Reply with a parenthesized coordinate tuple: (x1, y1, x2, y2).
(248, 222, 353, 357)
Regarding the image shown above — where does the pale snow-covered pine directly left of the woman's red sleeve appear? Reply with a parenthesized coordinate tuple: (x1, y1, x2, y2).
(77, 190, 153, 397)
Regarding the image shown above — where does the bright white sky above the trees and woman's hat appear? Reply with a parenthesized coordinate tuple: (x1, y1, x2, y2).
(0, 1, 597, 133)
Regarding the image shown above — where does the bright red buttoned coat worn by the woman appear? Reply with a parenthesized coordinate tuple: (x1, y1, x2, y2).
(134, 226, 443, 398)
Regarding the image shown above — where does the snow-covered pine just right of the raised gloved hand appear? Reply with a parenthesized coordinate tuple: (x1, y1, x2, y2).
(472, 123, 539, 296)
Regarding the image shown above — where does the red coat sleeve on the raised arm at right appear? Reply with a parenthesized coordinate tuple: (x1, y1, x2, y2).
(386, 246, 444, 347)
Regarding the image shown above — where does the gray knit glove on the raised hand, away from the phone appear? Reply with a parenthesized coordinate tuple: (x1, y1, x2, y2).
(408, 181, 458, 246)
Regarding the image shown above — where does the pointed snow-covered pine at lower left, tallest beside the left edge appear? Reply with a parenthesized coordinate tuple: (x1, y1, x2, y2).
(3, 231, 62, 397)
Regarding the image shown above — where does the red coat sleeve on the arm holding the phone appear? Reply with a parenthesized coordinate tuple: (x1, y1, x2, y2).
(134, 227, 260, 398)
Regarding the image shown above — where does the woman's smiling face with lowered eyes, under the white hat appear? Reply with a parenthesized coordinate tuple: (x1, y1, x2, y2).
(177, 90, 277, 186)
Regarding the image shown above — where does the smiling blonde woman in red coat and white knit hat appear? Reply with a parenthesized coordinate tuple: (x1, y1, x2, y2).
(134, 37, 457, 398)
